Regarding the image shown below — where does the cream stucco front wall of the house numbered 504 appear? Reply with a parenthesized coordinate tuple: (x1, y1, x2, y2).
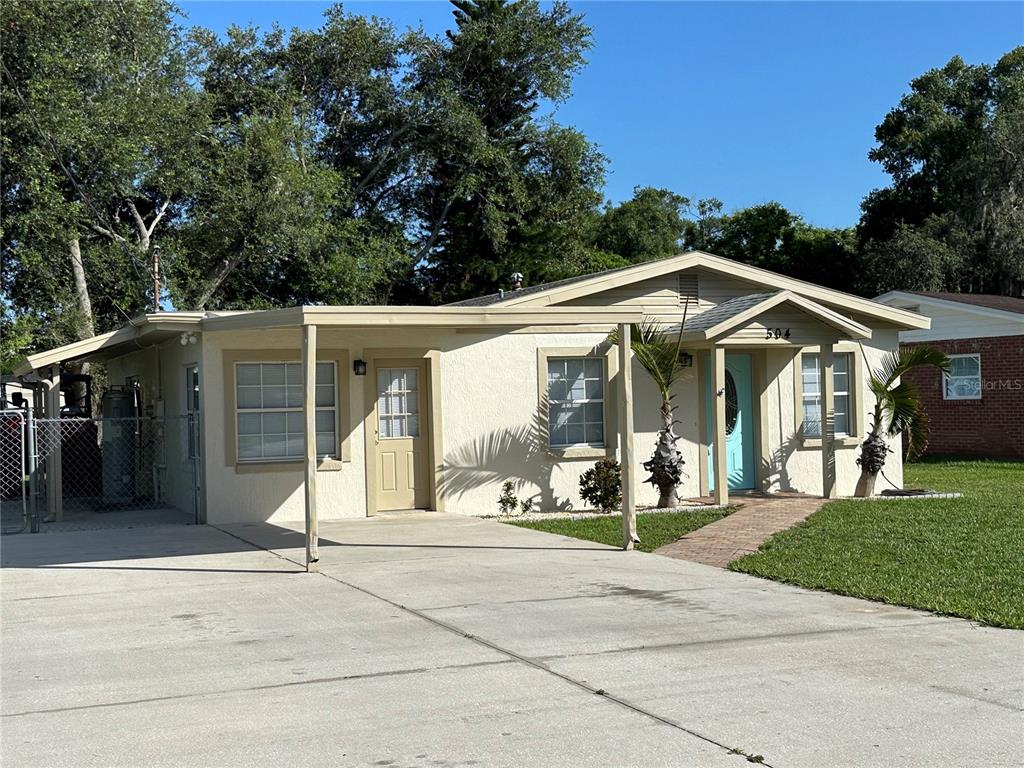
(192, 319, 902, 522)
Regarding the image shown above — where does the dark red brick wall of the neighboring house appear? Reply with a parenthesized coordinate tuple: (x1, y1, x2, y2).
(902, 336, 1024, 458)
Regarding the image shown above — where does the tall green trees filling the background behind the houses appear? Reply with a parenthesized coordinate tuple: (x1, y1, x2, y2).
(0, 0, 1024, 370)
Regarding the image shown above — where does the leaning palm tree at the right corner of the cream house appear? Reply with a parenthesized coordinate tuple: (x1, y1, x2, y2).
(854, 347, 949, 497)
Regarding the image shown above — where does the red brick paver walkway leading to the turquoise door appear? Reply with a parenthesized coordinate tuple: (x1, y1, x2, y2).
(655, 494, 826, 568)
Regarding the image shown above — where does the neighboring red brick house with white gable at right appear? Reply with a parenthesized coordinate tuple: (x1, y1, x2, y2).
(876, 291, 1024, 458)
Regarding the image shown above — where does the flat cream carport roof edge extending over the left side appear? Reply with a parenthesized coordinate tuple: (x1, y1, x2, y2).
(14, 306, 643, 376)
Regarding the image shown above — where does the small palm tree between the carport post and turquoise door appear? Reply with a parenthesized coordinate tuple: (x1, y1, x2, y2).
(608, 306, 687, 508)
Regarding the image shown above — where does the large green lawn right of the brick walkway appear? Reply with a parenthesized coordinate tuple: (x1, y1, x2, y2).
(729, 460, 1024, 629)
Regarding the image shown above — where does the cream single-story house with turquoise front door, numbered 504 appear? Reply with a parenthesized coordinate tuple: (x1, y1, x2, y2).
(18, 252, 929, 565)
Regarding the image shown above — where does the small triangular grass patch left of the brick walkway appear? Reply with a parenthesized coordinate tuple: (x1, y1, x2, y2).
(508, 509, 732, 552)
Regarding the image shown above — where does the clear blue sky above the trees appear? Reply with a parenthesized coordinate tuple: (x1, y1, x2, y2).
(181, 1, 1024, 226)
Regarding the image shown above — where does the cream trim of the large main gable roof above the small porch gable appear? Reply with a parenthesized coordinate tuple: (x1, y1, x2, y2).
(448, 251, 931, 329)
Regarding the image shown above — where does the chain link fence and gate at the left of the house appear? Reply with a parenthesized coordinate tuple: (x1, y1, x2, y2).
(0, 412, 201, 532)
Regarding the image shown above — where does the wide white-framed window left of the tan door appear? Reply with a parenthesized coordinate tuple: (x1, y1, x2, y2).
(234, 362, 338, 462)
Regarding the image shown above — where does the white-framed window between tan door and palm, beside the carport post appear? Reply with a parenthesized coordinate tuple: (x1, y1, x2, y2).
(548, 357, 605, 447)
